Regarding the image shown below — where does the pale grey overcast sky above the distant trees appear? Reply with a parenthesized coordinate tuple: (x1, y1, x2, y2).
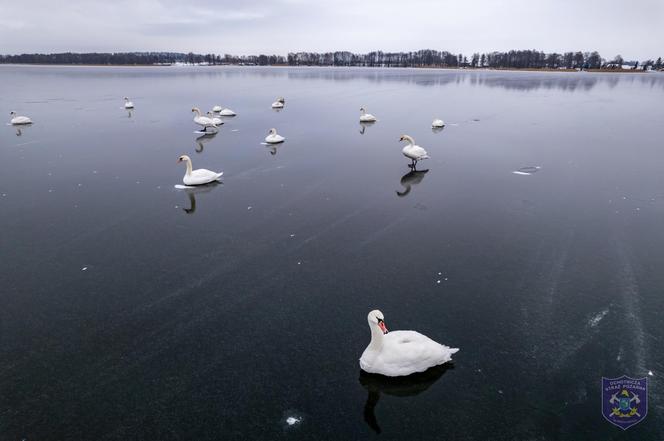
(0, 0, 664, 59)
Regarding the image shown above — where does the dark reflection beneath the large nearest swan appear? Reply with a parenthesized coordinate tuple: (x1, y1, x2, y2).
(359, 363, 454, 433)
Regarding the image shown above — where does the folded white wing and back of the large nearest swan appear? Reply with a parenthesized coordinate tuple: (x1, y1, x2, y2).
(372, 331, 458, 377)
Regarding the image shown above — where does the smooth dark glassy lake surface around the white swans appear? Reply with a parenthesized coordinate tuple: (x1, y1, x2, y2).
(0, 66, 664, 440)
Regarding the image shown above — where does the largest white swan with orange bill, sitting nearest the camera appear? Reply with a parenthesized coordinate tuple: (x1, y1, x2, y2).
(360, 309, 459, 377)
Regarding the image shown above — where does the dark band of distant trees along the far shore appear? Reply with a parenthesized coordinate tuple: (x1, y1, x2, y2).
(0, 49, 664, 70)
